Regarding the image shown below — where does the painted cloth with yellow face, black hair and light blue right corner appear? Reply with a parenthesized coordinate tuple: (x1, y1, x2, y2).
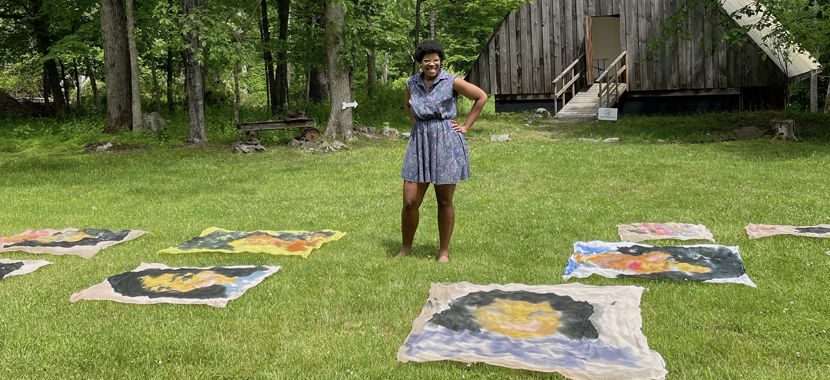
(69, 263, 280, 307)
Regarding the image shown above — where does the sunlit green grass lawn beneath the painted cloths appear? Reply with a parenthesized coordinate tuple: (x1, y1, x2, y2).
(0, 108, 830, 379)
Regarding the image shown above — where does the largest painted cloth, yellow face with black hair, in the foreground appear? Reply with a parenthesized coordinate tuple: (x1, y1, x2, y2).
(398, 282, 666, 379)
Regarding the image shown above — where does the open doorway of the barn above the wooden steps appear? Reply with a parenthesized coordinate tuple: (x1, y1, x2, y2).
(585, 16, 622, 83)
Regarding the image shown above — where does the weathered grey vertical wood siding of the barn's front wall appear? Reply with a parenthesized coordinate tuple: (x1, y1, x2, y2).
(467, 0, 787, 95)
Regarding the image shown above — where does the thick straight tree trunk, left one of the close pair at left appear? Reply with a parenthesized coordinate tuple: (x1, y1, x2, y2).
(100, 0, 133, 133)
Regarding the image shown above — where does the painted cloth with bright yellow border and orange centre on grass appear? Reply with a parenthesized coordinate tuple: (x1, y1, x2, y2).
(158, 227, 346, 258)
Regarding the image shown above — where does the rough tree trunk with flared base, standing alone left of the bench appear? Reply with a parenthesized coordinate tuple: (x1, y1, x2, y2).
(182, 0, 209, 146)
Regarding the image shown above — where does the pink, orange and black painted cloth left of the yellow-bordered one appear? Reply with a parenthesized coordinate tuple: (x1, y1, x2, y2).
(0, 228, 148, 259)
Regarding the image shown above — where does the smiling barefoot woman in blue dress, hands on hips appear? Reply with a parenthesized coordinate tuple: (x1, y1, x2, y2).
(396, 40, 487, 263)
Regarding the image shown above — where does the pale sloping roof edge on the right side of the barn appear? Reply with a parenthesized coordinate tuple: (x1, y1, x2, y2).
(723, 0, 821, 83)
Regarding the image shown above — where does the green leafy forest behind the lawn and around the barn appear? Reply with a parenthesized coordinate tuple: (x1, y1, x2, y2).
(0, 0, 830, 150)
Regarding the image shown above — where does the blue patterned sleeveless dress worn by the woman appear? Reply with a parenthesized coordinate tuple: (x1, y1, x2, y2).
(401, 70, 470, 185)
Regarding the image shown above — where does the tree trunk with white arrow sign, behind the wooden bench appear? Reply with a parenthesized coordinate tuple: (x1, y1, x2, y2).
(325, 0, 352, 140)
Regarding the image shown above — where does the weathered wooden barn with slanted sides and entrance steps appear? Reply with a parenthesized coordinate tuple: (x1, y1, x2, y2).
(466, 0, 820, 119)
